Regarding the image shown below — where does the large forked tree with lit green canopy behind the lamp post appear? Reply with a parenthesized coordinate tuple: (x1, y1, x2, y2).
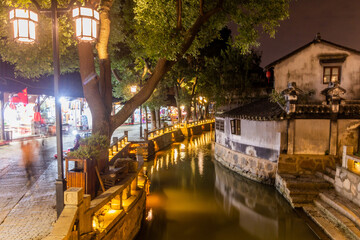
(0, 0, 290, 171)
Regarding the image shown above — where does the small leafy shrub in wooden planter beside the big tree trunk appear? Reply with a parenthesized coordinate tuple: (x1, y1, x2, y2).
(68, 134, 109, 161)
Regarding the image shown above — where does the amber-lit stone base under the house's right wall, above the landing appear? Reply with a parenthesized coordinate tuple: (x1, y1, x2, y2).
(278, 154, 339, 174)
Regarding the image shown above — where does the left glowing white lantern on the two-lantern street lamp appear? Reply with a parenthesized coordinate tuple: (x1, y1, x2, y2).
(9, 9, 38, 43)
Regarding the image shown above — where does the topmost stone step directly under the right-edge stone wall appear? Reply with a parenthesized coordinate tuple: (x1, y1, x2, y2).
(319, 192, 360, 228)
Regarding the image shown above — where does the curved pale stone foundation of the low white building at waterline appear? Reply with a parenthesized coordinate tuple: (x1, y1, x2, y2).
(215, 143, 277, 184)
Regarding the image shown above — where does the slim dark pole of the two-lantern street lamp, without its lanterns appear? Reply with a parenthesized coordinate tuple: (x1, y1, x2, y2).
(51, 0, 66, 217)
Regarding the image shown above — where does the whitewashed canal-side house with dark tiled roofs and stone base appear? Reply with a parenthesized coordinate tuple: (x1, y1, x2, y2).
(215, 36, 360, 184)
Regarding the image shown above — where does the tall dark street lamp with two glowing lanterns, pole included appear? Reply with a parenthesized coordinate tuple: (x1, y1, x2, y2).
(9, 0, 99, 217)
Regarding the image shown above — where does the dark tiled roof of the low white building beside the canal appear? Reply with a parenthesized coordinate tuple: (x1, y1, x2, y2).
(219, 98, 286, 121)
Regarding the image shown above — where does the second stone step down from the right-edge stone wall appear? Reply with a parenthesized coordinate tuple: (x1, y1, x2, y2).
(314, 199, 360, 240)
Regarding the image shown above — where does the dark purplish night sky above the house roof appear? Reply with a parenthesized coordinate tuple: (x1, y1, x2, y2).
(259, 0, 360, 67)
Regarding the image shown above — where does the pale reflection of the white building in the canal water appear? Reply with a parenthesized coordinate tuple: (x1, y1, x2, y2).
(215, 163, 312, 240)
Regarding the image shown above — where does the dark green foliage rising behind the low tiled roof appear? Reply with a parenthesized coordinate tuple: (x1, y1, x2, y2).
(198, 47, 263, 105)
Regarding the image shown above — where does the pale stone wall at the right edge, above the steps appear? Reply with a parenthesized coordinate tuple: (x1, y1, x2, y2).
(335, 167, 360, 206)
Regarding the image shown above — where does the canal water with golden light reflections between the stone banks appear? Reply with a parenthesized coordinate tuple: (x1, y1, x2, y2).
(137, 132, 317, 240)
